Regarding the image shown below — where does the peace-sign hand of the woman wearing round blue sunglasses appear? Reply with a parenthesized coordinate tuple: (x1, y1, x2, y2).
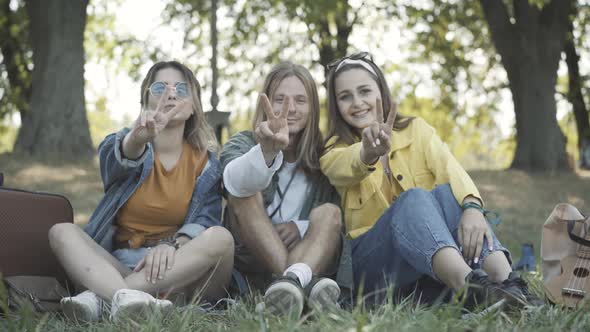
(130, 86, 191, 145)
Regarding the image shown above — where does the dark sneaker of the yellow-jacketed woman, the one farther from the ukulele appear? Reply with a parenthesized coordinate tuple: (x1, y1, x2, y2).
(464, 269, 525, 311)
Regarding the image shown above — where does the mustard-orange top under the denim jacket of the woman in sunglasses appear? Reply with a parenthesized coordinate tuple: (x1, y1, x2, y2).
(116, 141, 207, 248)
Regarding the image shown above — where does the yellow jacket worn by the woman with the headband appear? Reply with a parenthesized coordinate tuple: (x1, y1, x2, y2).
(320, 118, 483, 238)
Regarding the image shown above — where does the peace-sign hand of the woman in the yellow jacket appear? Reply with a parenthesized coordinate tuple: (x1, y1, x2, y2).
(361, 98, 397, 165)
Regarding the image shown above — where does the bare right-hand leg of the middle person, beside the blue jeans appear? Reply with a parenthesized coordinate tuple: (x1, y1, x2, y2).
(287, 203, 342, 275)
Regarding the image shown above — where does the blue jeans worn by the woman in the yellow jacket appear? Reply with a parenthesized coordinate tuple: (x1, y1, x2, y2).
(352, 184, 510, 304)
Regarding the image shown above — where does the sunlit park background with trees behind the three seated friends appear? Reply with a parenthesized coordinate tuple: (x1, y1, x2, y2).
(0, 0, 590, 329)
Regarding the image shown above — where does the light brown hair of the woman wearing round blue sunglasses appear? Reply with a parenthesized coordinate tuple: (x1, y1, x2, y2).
(140, 61, 219, 152)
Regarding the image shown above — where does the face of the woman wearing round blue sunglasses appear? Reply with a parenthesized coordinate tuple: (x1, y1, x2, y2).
(147, 67, 193, 122)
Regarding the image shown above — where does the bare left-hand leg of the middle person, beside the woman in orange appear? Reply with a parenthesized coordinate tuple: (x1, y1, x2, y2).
(228, 193, 288, 274)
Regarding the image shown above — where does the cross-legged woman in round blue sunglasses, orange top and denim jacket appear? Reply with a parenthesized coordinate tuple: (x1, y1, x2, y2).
(49, 61, 234, 321)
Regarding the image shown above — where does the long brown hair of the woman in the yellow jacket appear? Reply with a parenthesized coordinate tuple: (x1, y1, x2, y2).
(326, 52, 414, 147)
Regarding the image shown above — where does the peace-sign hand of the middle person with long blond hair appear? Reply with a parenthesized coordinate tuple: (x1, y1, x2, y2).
(254, 93, 291, 165)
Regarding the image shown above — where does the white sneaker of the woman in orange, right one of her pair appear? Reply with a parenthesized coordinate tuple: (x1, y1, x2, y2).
(111, 289, 172, 321)
